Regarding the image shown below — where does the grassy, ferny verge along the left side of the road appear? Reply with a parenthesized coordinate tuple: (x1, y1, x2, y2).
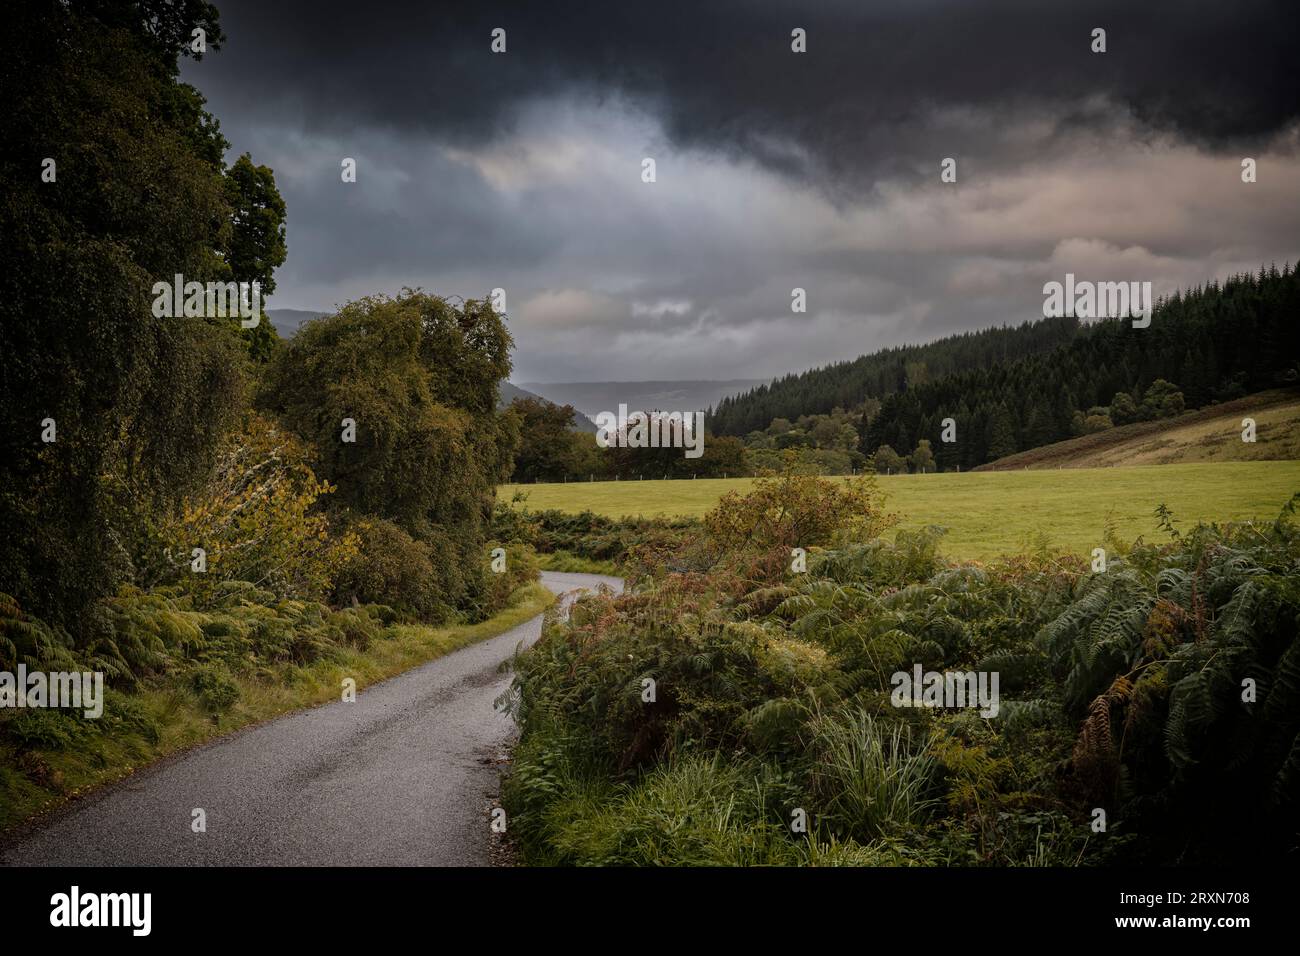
(0, 583, 555, 832)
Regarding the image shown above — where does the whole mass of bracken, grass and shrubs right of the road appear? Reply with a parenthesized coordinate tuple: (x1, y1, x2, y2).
(504, 476, 1300, 866)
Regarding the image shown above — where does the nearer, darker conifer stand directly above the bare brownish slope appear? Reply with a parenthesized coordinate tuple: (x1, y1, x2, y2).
(862, 265, 1300, 468)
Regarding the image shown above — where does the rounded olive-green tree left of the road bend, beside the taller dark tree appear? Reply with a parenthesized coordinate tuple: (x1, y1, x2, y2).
(259, 290, 519, 614)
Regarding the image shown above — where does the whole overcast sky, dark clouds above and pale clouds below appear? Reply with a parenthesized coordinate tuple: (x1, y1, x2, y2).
(183, 0, 1300, 381)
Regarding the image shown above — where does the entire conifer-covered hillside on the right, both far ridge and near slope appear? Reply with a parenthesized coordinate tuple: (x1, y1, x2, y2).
(710, 265, 1300, 470)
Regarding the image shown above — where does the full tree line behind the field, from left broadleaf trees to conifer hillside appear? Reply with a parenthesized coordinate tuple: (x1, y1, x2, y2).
(514, 264, 1300, 481)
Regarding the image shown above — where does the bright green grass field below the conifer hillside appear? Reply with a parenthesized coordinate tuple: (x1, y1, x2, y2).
(498, 462, 1300, 558)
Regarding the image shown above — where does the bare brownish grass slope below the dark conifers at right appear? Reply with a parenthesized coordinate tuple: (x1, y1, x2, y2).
(974, 389, 1300, 471)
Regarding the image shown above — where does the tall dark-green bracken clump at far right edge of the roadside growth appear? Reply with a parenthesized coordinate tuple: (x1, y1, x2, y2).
(1040, 514, 1300, 860)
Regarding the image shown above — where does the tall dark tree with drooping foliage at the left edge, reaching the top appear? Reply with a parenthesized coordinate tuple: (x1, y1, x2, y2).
(0, 0, 282, 641)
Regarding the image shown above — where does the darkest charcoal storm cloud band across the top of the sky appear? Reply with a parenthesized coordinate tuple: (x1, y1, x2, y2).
(195, 0, 1300, 181)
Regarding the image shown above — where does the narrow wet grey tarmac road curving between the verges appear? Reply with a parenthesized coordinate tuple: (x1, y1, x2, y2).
(0, 572, 621, 866)
